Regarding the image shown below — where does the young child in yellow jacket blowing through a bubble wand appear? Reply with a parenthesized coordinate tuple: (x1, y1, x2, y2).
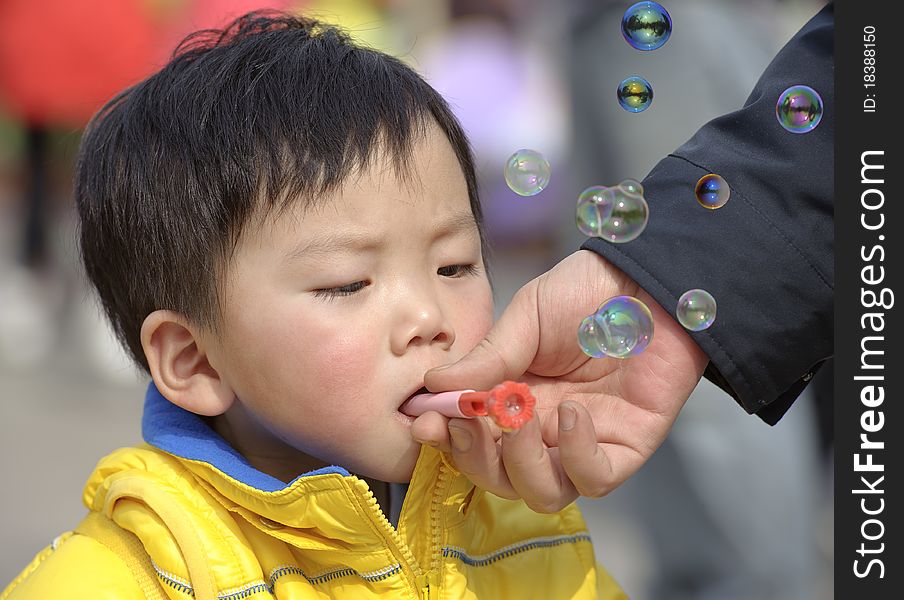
(0, 13, 623, 600)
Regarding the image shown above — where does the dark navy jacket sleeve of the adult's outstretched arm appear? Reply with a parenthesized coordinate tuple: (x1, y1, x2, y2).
(583, 5, 835, 424)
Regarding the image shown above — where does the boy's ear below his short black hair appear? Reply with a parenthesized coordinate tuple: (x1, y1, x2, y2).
(141, 310, 235, 417)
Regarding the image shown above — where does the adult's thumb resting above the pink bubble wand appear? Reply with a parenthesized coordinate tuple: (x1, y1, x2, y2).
(424, 279, 540, 392)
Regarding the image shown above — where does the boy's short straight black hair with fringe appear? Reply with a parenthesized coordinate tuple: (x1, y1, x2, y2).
(75, 11, 486, 372)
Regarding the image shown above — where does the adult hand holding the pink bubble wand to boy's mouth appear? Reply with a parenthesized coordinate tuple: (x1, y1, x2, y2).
(412, 250, 708, 512)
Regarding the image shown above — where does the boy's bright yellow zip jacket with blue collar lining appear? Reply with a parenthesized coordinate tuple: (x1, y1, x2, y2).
(0, 386, 626, 600)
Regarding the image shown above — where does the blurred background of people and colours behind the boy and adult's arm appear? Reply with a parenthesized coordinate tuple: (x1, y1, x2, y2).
(0, 0, 833, 600)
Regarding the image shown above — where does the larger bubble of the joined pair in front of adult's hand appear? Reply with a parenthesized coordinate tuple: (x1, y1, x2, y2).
(585, 296, 653, 358)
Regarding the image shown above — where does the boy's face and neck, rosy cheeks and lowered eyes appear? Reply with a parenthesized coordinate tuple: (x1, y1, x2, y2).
(204, 126, 493, 482)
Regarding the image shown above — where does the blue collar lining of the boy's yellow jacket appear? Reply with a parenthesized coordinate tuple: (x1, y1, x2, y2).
(141, 381, 349, 492)
